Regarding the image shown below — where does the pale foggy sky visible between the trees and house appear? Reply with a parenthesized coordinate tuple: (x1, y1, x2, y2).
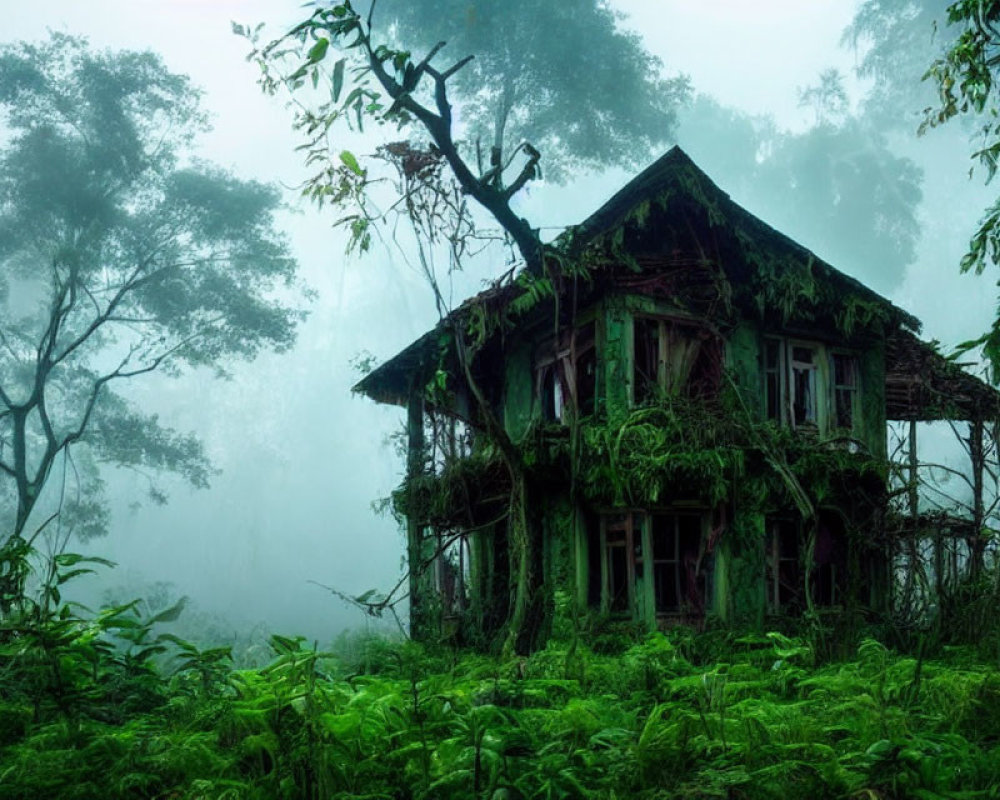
(0, 0, 994, 639)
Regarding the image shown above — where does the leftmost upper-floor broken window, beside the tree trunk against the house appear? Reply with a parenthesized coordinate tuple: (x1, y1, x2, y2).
(535, 322, 597, 422)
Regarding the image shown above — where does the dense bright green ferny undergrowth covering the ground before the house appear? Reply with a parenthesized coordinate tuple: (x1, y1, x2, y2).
(0, 556, 1000, 800)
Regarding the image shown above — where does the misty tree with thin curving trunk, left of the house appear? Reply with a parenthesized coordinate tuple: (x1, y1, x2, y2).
(0, 34, 302, 556)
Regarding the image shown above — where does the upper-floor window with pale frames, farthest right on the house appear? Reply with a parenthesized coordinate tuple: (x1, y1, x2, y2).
(763, 338, 858, 430)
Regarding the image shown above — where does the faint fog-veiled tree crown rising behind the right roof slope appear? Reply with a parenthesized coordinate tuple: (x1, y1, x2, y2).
(680, 86, 922, 291)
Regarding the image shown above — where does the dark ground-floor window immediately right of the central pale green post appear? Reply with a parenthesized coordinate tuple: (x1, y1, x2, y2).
(651, 514, 705, 614)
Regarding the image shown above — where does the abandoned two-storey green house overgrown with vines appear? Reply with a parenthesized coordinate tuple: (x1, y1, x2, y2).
(355, 147, 998, 643)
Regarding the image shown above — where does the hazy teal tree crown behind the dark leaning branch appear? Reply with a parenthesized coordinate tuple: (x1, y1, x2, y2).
(373, 0, 688, 179)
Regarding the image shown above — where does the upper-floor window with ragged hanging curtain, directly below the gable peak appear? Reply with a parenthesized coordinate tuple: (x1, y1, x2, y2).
(632, 317, 722, 405)
